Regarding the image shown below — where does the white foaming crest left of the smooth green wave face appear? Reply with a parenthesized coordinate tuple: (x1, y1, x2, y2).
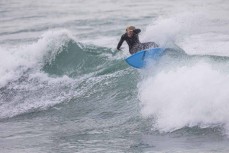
(0, 30, 74, 87)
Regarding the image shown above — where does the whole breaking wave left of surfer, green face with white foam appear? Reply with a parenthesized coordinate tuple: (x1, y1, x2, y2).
(0, 30, 131, 118)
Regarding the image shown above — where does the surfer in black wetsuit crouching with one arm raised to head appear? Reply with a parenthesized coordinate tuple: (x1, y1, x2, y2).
(117, 26, 158, 54)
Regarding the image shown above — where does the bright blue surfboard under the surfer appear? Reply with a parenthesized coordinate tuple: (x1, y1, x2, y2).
(125, 48, 165, 68)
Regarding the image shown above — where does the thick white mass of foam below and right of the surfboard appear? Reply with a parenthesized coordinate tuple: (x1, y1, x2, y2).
(138, 62, 229, 133)
